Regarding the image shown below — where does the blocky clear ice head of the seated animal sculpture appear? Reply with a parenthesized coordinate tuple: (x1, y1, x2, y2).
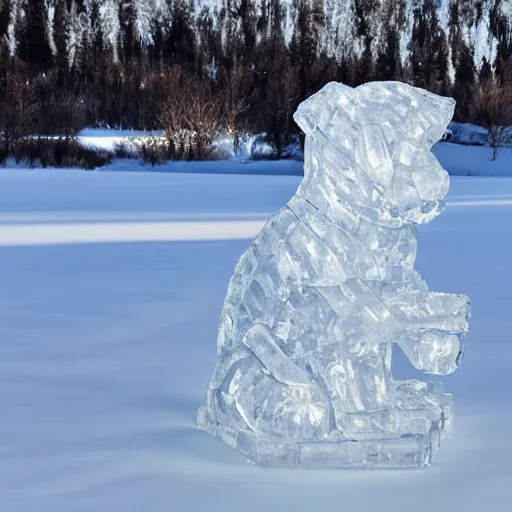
(294, 82, 455, 226)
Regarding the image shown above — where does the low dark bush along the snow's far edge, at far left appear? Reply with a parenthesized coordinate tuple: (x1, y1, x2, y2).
(12, 137, 112, 170)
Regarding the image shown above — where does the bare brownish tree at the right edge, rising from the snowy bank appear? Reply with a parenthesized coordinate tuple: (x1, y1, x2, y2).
(473, 80, 512, 161)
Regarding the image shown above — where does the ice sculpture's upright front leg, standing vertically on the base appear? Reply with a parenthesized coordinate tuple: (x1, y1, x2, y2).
(315, 278, 401, 439)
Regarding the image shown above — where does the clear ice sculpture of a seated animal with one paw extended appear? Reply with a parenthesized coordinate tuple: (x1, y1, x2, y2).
(198, 82, 469, 468)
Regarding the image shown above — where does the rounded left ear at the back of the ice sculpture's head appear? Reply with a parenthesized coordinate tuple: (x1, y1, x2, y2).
(293, 82, 356, 136)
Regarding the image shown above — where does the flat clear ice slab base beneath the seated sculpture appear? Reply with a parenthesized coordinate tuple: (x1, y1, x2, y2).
(197, 382, 453, 469)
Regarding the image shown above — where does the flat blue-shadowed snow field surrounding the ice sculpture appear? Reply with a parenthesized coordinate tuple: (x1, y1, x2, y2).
(0, 169, 512, 512)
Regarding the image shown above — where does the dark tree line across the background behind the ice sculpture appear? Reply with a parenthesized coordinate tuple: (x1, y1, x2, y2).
(0, 0, 512, 159)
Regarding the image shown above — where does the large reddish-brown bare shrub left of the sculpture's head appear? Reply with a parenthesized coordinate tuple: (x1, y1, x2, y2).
(158, 66, 222, 159)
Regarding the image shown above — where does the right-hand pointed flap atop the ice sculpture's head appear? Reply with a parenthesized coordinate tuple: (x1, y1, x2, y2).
(357, 82, 455, 148)
